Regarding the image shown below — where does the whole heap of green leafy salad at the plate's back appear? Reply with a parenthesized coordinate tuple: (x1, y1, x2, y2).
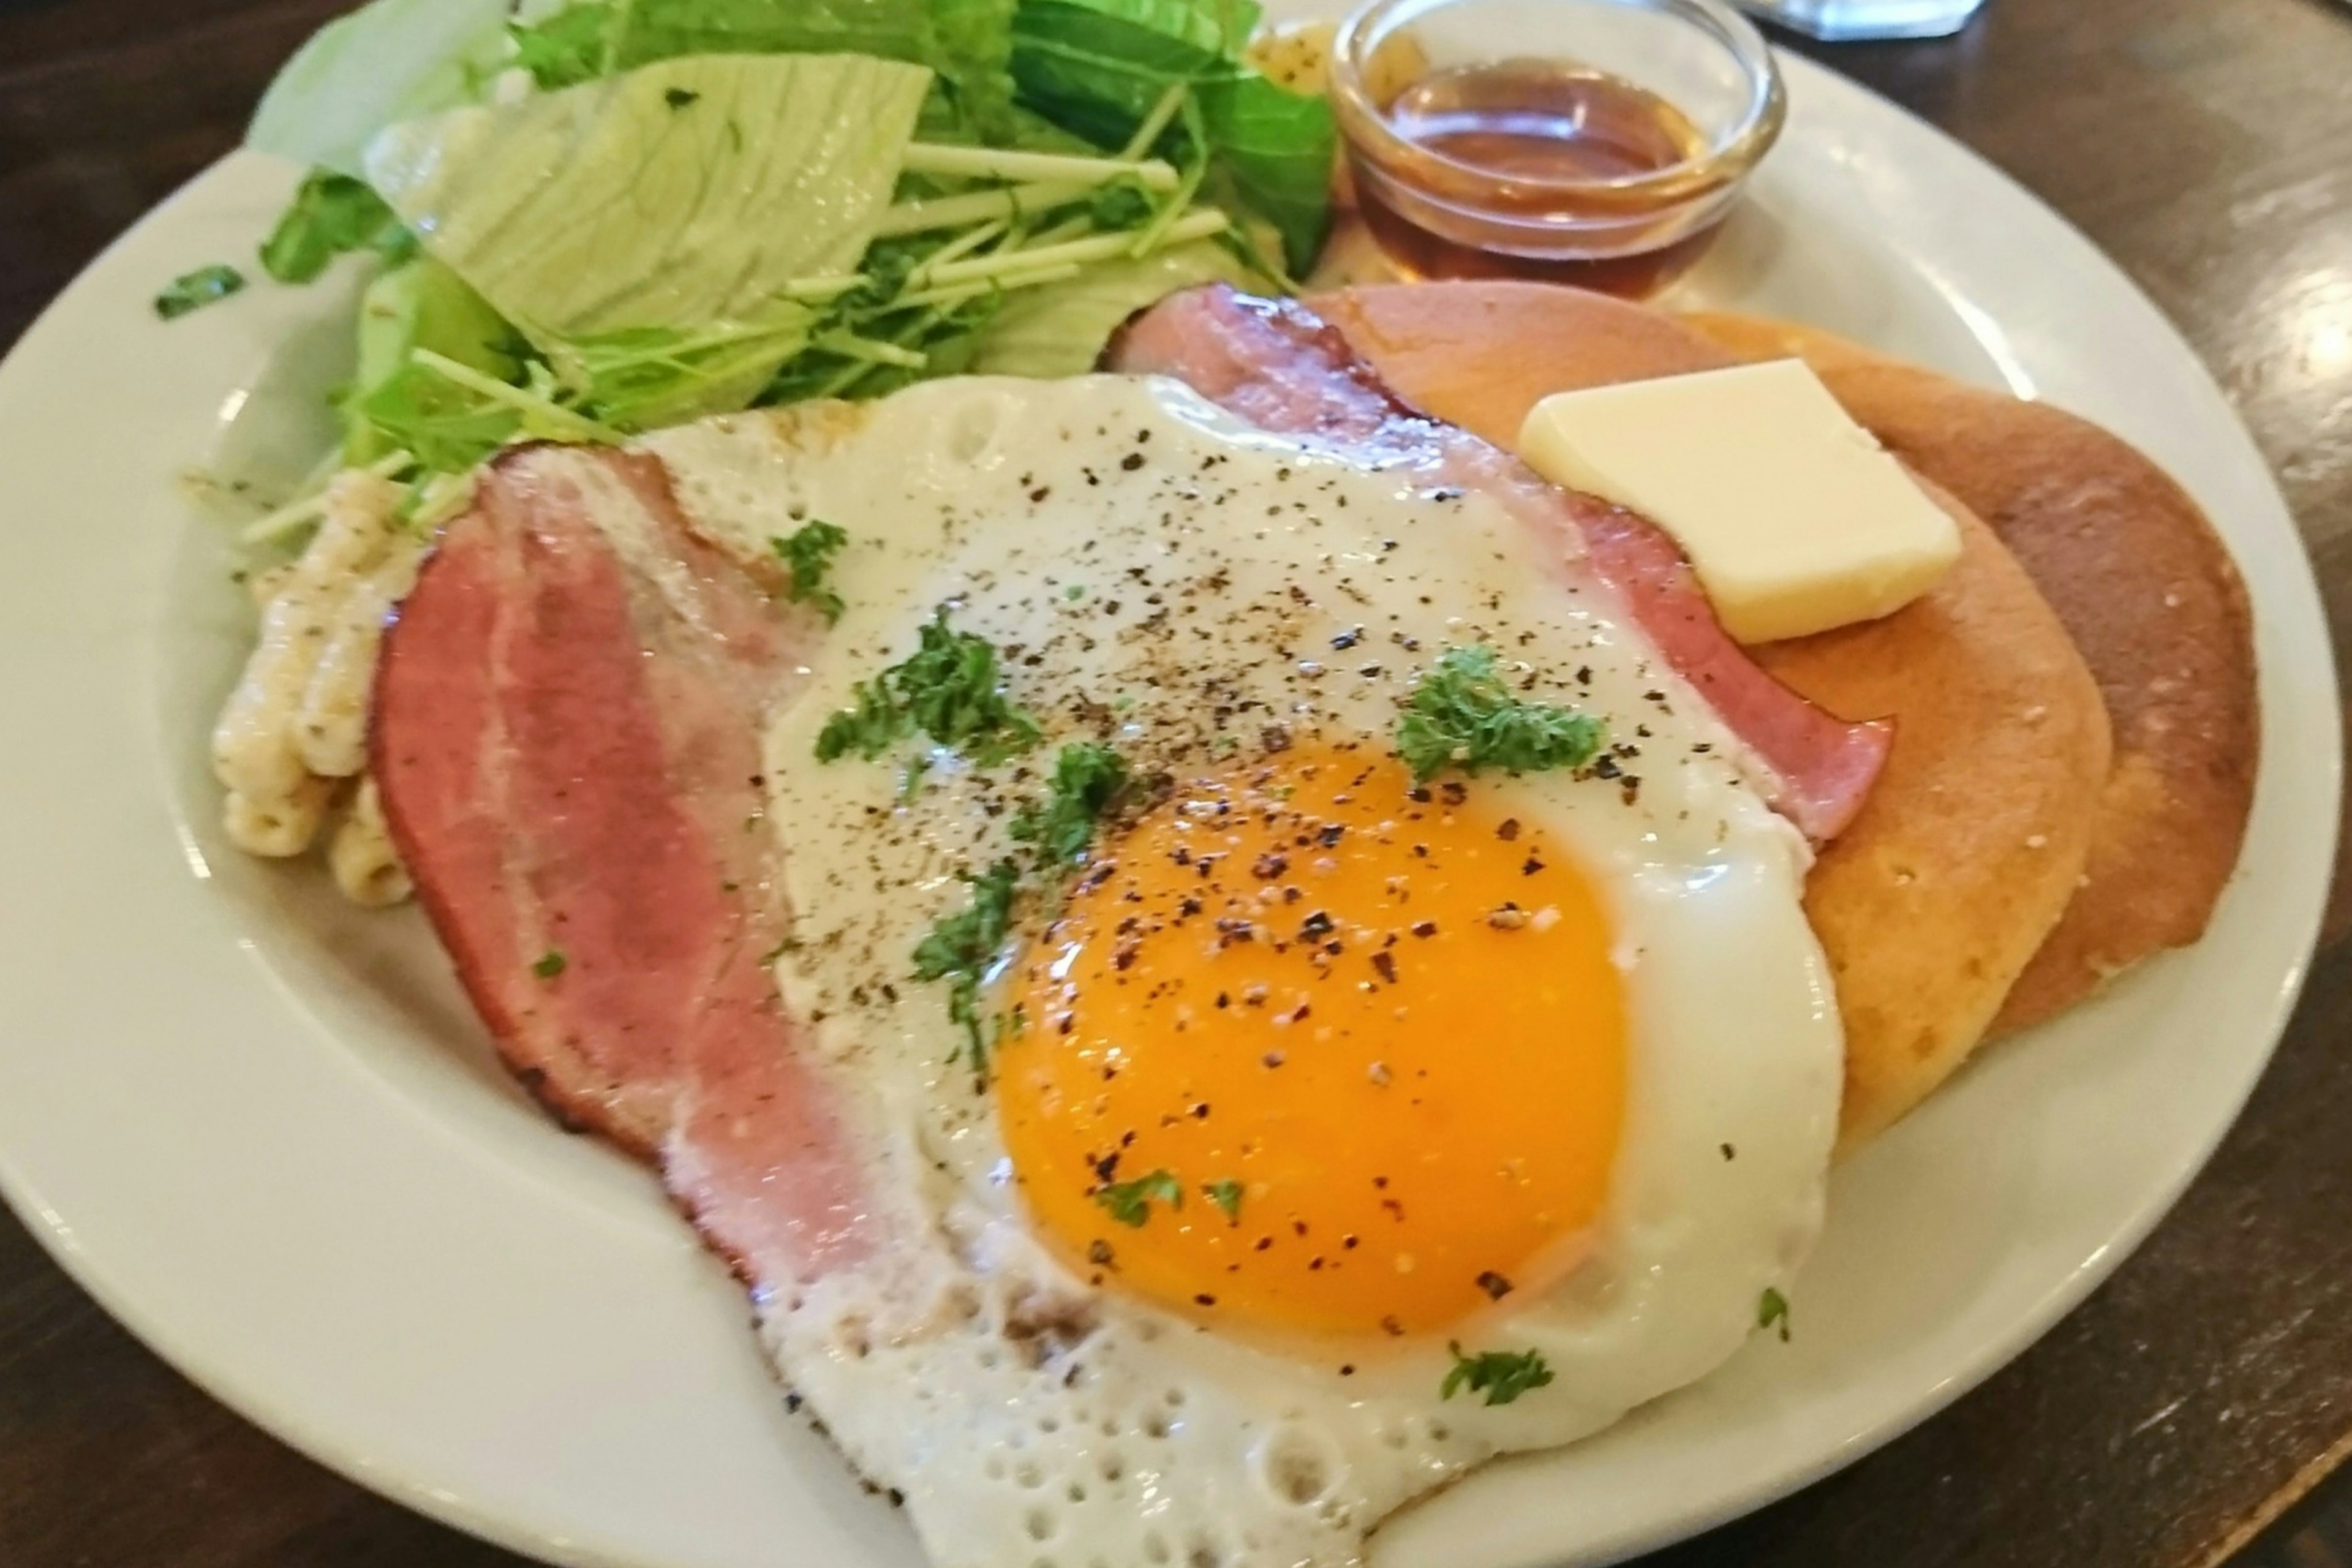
(222, 0, 1333, 527)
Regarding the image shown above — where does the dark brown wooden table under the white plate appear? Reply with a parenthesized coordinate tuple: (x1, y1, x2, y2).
(0, 0, 2352, 1568)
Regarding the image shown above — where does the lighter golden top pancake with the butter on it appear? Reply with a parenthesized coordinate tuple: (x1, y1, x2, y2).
(1313, 282, 2108, 1147)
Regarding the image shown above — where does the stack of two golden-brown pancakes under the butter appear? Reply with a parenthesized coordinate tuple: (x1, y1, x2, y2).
(1313, 282, 2258, 1150)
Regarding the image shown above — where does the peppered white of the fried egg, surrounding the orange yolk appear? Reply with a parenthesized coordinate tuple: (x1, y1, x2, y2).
(647, 376, 1842, 1568)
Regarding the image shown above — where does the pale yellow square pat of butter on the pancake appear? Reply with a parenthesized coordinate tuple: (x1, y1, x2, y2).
(1520, 360, 1959, 642)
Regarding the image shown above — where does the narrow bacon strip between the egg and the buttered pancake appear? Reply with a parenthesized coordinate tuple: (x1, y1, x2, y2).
(1106, 284, 1893, 844)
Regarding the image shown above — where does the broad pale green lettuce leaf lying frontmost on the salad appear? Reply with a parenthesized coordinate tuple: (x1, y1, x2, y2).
(367, 54, 932, 334)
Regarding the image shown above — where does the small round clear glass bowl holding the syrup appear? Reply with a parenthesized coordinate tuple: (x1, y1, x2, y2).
(1331, 0, 1787, 296)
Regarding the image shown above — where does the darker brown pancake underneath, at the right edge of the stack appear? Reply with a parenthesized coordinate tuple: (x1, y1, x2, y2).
(1689, 315, 2260, 1030)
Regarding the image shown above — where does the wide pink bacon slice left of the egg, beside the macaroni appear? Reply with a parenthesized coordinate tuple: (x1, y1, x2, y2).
(372, 447, 873, 1288)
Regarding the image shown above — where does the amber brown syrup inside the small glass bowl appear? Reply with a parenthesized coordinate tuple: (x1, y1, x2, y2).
(1355, 59, 1728, 298)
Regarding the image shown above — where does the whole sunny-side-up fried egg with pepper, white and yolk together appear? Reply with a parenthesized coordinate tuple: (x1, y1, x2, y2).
(649, 376, 1842, 1568)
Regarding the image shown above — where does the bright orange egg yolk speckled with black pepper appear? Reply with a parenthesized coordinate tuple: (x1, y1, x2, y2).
(995, 745, 1625, 1335)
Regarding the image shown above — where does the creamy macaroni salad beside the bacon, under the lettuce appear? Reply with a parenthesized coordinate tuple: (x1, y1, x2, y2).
(212, 470, 423, 905)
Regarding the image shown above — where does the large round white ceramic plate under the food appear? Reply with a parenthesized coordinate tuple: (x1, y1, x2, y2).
(0, 46, 2338, 1568)
